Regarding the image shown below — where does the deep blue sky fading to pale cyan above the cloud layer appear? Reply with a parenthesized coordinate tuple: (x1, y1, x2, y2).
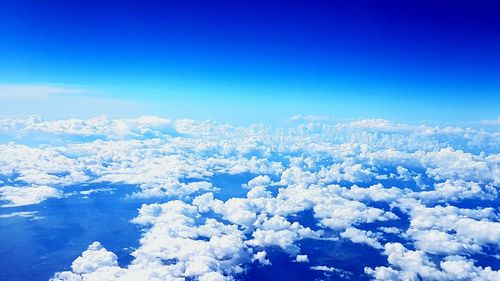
(0, 0, 500, 122)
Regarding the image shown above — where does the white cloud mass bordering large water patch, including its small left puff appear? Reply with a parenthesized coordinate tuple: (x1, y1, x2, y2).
(55, 200, 252, 280)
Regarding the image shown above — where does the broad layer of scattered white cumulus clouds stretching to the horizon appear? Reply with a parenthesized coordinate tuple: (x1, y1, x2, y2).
(0, 116, 500, 280)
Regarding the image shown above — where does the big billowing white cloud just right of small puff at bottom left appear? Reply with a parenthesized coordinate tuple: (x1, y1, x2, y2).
(133, 201, 251, 278)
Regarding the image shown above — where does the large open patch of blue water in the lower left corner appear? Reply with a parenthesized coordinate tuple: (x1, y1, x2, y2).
(0, 184, 143, 281)
